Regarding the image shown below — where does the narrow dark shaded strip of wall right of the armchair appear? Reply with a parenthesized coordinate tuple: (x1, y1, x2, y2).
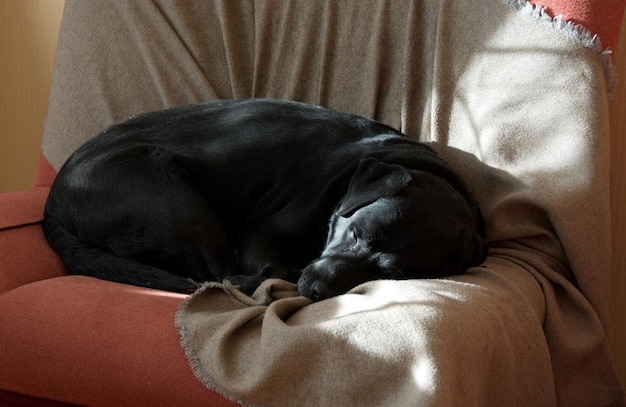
(610, 11, 626, 384)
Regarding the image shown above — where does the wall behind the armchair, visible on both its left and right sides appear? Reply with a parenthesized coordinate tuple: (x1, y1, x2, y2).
(0, 0, 626, 392)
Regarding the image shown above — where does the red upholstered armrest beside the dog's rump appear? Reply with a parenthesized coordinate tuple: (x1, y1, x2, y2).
(0, 188, 67, 293)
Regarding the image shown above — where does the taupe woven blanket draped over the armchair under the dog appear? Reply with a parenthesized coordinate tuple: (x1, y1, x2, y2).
(44, 0, 623, 407)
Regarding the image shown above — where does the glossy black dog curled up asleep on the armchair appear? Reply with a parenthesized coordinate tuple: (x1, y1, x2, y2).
(43, 99, 486, 300)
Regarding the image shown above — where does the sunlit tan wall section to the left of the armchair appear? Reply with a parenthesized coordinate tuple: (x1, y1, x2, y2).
(0, 0, 64, 192)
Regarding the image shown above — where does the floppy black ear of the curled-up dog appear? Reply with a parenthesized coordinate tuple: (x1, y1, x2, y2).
(337, 158, 411, 217)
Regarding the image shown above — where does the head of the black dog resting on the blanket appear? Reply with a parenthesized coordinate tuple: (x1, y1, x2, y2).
(298, 159, 487, 301)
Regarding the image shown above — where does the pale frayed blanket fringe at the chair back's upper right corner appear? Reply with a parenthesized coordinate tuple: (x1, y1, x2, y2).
(502, 0, 616, 93)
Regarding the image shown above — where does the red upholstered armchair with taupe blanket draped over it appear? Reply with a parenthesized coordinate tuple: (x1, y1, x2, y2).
(0, 0, 626, 406)
